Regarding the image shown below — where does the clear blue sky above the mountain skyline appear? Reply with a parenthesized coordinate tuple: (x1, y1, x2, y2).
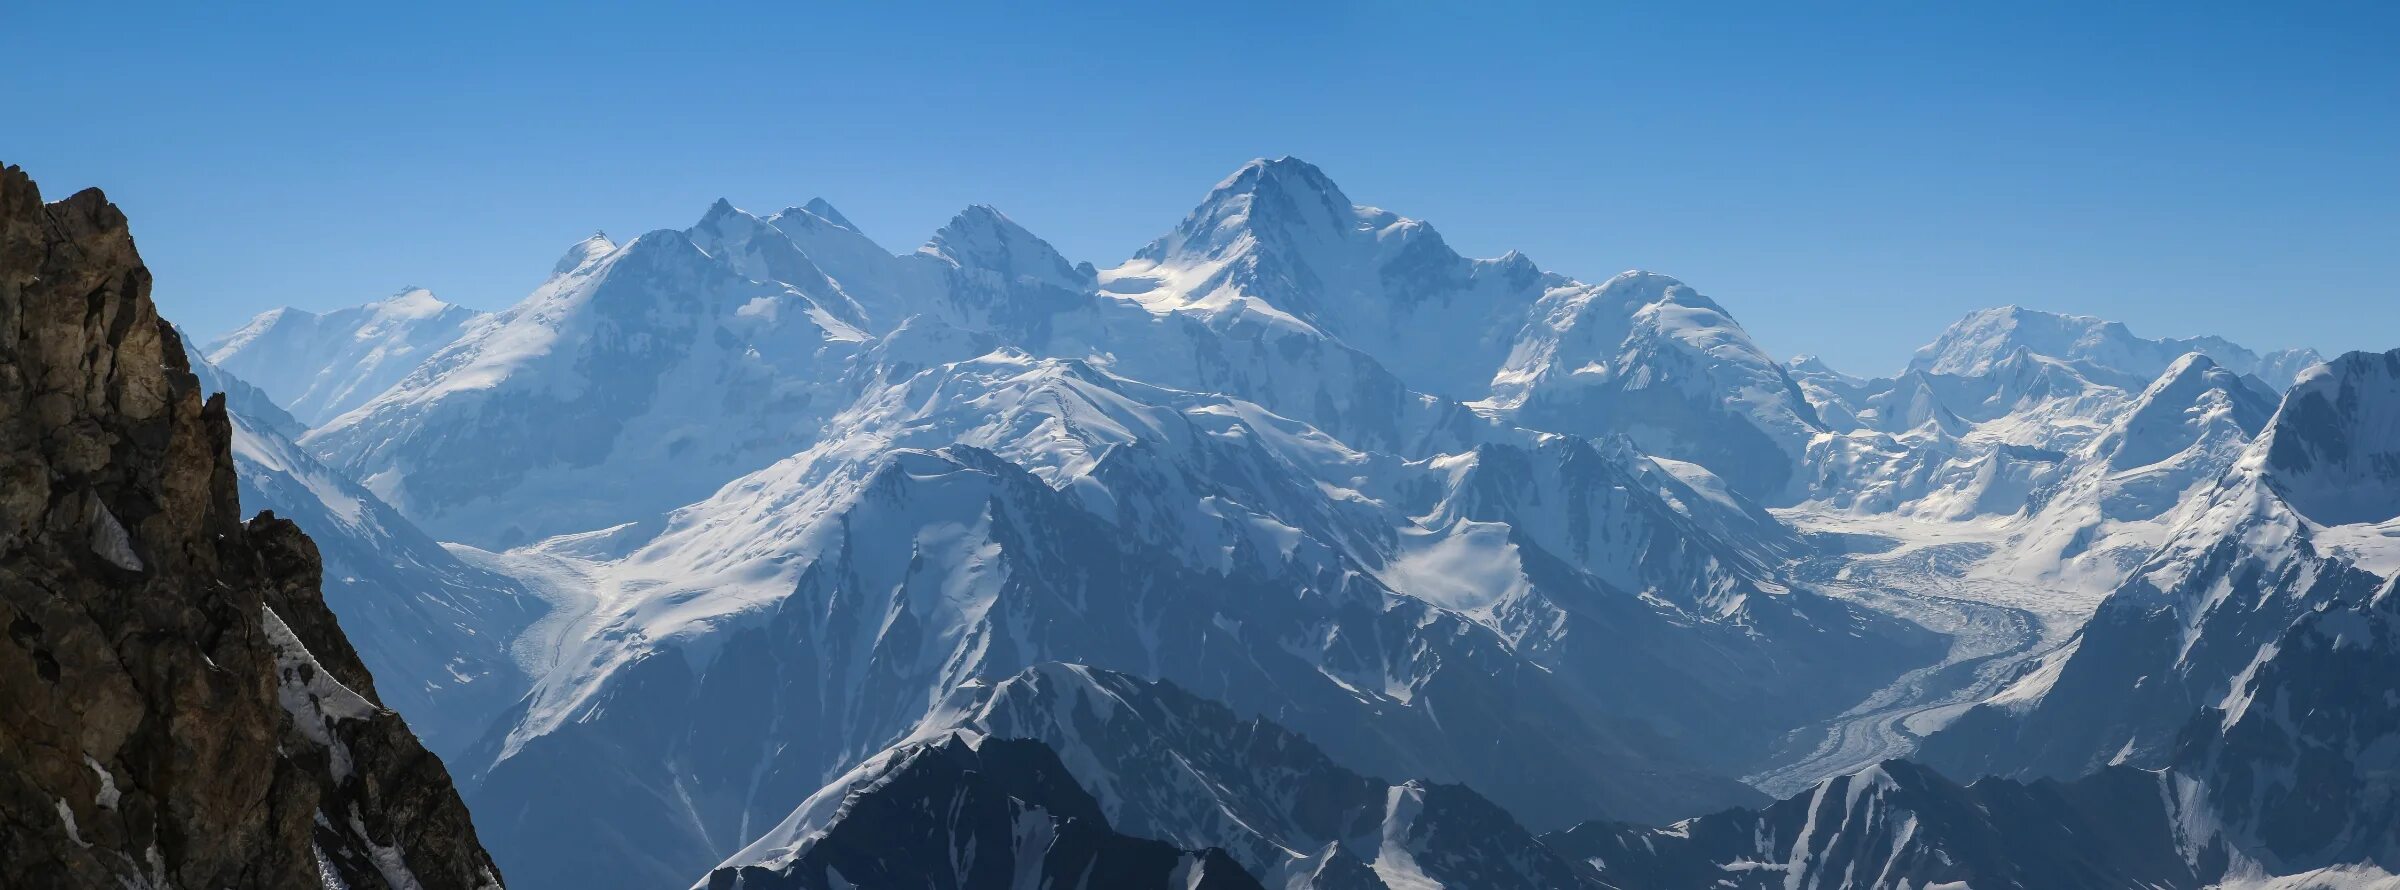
(0, 2, 2400, 372)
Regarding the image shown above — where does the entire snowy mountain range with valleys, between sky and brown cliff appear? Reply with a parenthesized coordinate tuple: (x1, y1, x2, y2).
(9, 158, 2400, 890)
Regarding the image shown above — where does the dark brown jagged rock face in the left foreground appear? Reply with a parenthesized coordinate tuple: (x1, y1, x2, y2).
(0, 168, 499, 890)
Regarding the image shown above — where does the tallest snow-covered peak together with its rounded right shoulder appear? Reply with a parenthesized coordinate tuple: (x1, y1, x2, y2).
(1099, 158, 1817, 501)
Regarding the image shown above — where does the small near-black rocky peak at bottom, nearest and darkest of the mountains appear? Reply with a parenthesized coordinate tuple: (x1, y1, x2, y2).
(694, 732, 1258, 890)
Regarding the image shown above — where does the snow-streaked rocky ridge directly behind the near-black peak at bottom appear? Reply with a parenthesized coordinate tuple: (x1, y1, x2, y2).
(713, 665, 1608, 890)
